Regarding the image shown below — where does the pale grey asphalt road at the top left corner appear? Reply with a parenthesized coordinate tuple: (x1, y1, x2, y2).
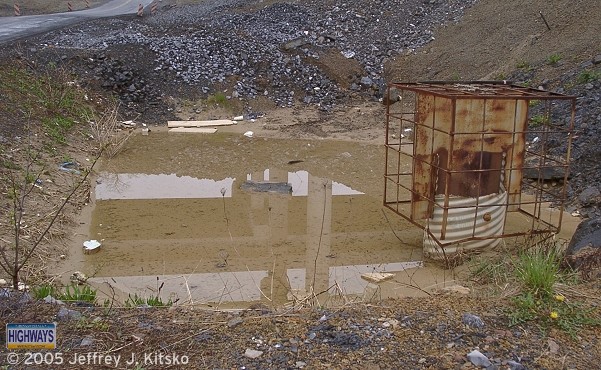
(0, 0, 152, 44)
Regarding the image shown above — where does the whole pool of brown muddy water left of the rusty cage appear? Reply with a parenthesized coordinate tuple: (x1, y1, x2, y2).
(57, 131, 580, 308)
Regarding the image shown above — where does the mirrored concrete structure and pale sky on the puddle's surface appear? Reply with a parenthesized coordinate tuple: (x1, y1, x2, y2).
(86, 169, 421, 305)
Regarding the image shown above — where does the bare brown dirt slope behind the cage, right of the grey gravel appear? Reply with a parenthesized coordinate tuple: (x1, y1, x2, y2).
(391, 0, 601, 83)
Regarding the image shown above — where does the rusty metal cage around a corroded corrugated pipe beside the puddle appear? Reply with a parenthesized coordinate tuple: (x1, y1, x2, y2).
(384, 81, 576, 258)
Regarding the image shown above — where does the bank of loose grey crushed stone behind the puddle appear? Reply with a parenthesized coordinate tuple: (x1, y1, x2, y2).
(39, 0, 475, 111)
